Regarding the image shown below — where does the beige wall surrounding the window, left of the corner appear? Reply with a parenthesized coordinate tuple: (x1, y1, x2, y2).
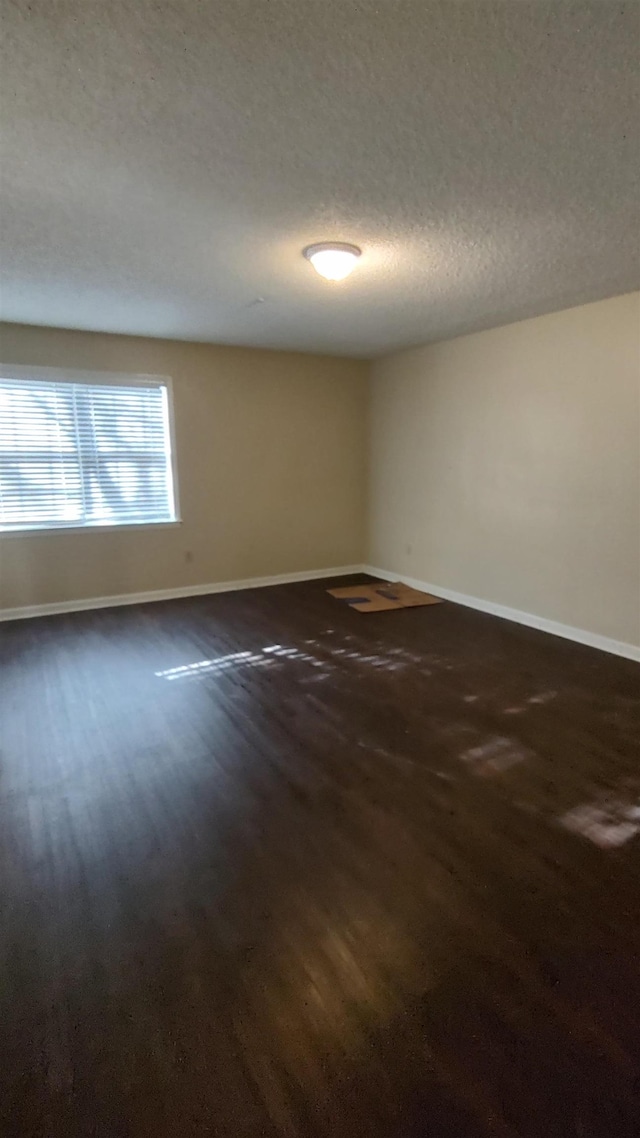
(0, 324, 368, 608)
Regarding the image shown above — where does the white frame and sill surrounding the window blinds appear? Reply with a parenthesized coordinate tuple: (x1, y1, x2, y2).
(0, 363, 182, 542)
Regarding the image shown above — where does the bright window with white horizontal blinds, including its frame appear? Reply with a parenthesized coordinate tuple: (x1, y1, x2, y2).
(0, 368, 177, 531)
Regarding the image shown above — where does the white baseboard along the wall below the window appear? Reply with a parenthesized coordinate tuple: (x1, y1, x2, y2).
(0, 566, 362, 620)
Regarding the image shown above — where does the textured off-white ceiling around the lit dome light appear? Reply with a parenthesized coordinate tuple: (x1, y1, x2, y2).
(0, 0, 640, 356)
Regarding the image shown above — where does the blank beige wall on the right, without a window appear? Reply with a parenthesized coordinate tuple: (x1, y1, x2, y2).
(369, 294, 640, 644)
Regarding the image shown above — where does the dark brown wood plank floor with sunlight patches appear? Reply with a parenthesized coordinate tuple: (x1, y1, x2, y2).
(0, 579, 640, 1138)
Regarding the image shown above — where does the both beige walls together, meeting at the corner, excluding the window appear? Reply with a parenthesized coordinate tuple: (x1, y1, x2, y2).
(0, 294, 640, 644)
